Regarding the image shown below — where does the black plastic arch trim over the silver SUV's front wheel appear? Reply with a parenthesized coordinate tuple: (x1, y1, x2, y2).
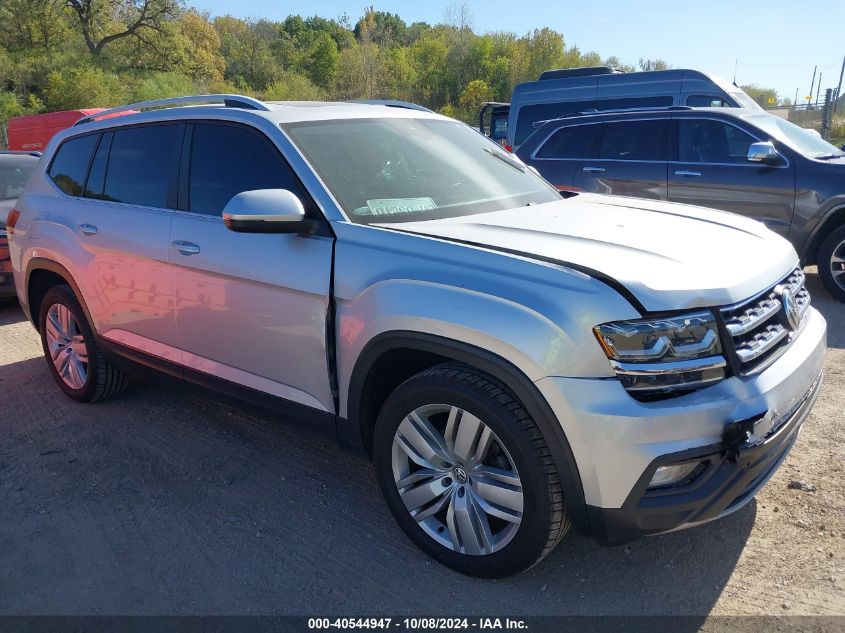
(346, 331, 591, 535)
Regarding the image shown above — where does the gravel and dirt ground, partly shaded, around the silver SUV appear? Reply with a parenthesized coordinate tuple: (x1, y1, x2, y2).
(0, 270, 845, 615)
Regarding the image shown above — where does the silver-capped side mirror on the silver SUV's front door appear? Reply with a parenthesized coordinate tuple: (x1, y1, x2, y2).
(223, 189, 320, 234)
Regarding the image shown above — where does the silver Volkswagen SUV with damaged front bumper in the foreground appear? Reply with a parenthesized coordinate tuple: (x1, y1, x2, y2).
(8, 95, 826, 576)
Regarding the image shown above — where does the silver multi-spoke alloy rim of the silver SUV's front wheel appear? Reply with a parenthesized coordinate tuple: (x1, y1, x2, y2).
(392, 404, 523, 556)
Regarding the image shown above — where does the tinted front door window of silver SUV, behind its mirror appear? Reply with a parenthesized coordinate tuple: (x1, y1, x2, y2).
(188, 123, 307, 215)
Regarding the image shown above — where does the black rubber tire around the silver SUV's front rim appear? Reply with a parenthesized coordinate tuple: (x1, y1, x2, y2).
(373, 363, 569, 578)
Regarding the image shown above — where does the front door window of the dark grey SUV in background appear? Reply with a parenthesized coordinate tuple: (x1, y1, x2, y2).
(678, 119, 756, 164)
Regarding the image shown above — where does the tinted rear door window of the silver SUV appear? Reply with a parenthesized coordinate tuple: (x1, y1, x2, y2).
(103, 124, 182, 208)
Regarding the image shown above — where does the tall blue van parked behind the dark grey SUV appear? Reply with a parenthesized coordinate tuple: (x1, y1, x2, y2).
(479, 66, 762, 151)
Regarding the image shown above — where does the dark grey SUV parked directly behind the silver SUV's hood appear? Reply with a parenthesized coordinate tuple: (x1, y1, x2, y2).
(517, 108, 845, 301)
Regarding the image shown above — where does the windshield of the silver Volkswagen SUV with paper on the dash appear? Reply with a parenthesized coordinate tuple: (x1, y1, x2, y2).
(284, 118, 560, 224)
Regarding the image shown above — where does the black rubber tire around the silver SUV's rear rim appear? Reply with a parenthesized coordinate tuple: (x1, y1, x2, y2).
(38, 285, 128, 402)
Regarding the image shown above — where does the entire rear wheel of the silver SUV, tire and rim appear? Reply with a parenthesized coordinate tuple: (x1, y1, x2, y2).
(38, 285, 127, 402)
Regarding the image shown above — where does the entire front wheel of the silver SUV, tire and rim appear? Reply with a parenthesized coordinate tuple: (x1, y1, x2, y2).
(373, 363, 569, 578)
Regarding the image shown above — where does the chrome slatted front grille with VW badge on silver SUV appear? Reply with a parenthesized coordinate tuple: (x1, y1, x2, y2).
(722, 267, 810, 374)
